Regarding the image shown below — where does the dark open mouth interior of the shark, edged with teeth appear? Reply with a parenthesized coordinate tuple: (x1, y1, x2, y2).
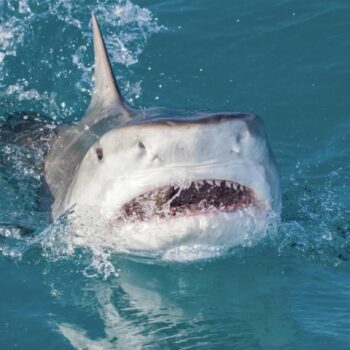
(120, 180, 255, 221)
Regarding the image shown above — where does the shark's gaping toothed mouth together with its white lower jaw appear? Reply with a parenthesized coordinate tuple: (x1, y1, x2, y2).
(70, 174, 278, 261)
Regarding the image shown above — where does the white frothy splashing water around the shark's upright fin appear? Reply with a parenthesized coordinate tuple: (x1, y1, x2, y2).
(0, 0, 166, 122)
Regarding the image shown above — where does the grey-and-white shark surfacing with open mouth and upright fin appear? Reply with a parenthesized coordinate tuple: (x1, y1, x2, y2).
(46, 16, 281, 256)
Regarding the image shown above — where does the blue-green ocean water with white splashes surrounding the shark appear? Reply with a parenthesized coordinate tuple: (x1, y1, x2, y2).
(0, 0, 350, 349)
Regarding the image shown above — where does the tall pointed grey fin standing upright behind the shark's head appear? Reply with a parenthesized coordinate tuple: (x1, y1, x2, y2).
(85, 14, 131, 125)
